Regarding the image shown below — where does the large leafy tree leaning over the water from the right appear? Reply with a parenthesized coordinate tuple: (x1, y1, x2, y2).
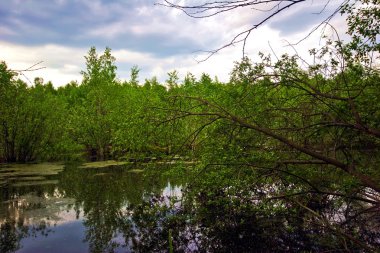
(154, 1, 380, 251)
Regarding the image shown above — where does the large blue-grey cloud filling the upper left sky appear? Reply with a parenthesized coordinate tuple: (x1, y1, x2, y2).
(0, 0, 220, 56)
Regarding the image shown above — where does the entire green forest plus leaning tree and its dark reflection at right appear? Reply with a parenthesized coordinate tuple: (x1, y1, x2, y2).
(0, 1, 380, 252)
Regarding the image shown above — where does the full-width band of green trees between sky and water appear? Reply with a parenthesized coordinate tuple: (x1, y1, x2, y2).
(0, 45, 380, 169)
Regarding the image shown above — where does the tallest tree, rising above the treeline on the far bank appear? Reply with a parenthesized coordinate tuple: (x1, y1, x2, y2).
(72, 47, 117, 160)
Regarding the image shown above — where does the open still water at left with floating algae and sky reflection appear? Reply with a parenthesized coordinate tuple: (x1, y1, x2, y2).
(0, 161, 183, 253)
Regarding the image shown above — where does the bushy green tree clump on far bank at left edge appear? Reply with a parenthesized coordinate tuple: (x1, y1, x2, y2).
(0, 63, 64, 162)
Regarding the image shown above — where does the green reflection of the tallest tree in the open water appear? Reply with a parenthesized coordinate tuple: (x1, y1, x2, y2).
(60, 163, 183, 253)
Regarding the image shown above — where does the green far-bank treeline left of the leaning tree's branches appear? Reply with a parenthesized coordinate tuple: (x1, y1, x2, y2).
(0, 48, 223, 162)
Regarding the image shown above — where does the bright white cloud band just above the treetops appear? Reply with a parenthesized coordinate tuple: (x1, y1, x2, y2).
(0, 23, 332, 87)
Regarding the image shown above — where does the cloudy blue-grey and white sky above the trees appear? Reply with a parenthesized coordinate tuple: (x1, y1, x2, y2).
(0, 0, 345, 87)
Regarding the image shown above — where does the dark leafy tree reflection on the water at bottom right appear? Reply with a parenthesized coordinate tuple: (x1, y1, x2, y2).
(121, 166, 380, 252)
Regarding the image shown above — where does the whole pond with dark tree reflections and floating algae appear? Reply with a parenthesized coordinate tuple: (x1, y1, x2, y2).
(0, 161, 380, 253)
